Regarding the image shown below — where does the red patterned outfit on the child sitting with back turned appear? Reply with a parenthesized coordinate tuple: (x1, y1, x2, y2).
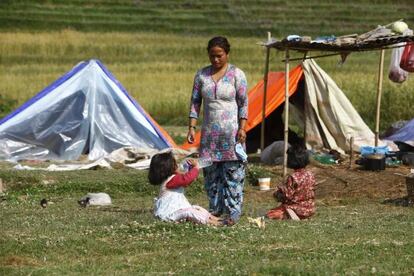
(267, 169, 316, 219)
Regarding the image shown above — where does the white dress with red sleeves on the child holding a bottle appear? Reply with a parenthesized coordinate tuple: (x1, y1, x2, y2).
(154, 168, 210, 224)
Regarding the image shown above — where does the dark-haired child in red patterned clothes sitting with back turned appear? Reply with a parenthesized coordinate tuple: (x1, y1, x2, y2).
(267, 146, 316, 220)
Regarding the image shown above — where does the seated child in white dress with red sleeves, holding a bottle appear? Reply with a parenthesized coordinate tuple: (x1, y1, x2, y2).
(148, 152, 220, 225)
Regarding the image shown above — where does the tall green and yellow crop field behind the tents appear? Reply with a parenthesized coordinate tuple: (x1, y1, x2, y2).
(0, 0, 414, 130)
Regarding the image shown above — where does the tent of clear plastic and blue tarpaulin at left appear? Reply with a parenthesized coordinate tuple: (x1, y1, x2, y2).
(0, 60, 174, 161)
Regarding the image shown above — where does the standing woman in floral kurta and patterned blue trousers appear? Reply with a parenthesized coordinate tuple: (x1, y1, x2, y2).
(187, 37, 248, 224)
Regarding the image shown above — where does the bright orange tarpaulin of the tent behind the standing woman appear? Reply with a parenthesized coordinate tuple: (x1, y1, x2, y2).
(181, 65, 303, 150)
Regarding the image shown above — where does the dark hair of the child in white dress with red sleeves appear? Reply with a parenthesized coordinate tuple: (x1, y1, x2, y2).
(148, 152, 177, 185)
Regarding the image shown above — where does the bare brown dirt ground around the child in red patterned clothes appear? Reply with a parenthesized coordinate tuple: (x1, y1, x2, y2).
(250, 162, 410, 205)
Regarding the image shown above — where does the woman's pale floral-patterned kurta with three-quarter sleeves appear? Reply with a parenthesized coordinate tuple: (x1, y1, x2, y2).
(190, 64, 247, 162)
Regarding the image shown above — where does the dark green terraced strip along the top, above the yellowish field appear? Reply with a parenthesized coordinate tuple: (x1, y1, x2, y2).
(0, 0, 414, 37)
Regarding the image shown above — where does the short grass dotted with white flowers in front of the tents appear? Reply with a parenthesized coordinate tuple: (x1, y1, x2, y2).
(0, 165, 414, 275)
